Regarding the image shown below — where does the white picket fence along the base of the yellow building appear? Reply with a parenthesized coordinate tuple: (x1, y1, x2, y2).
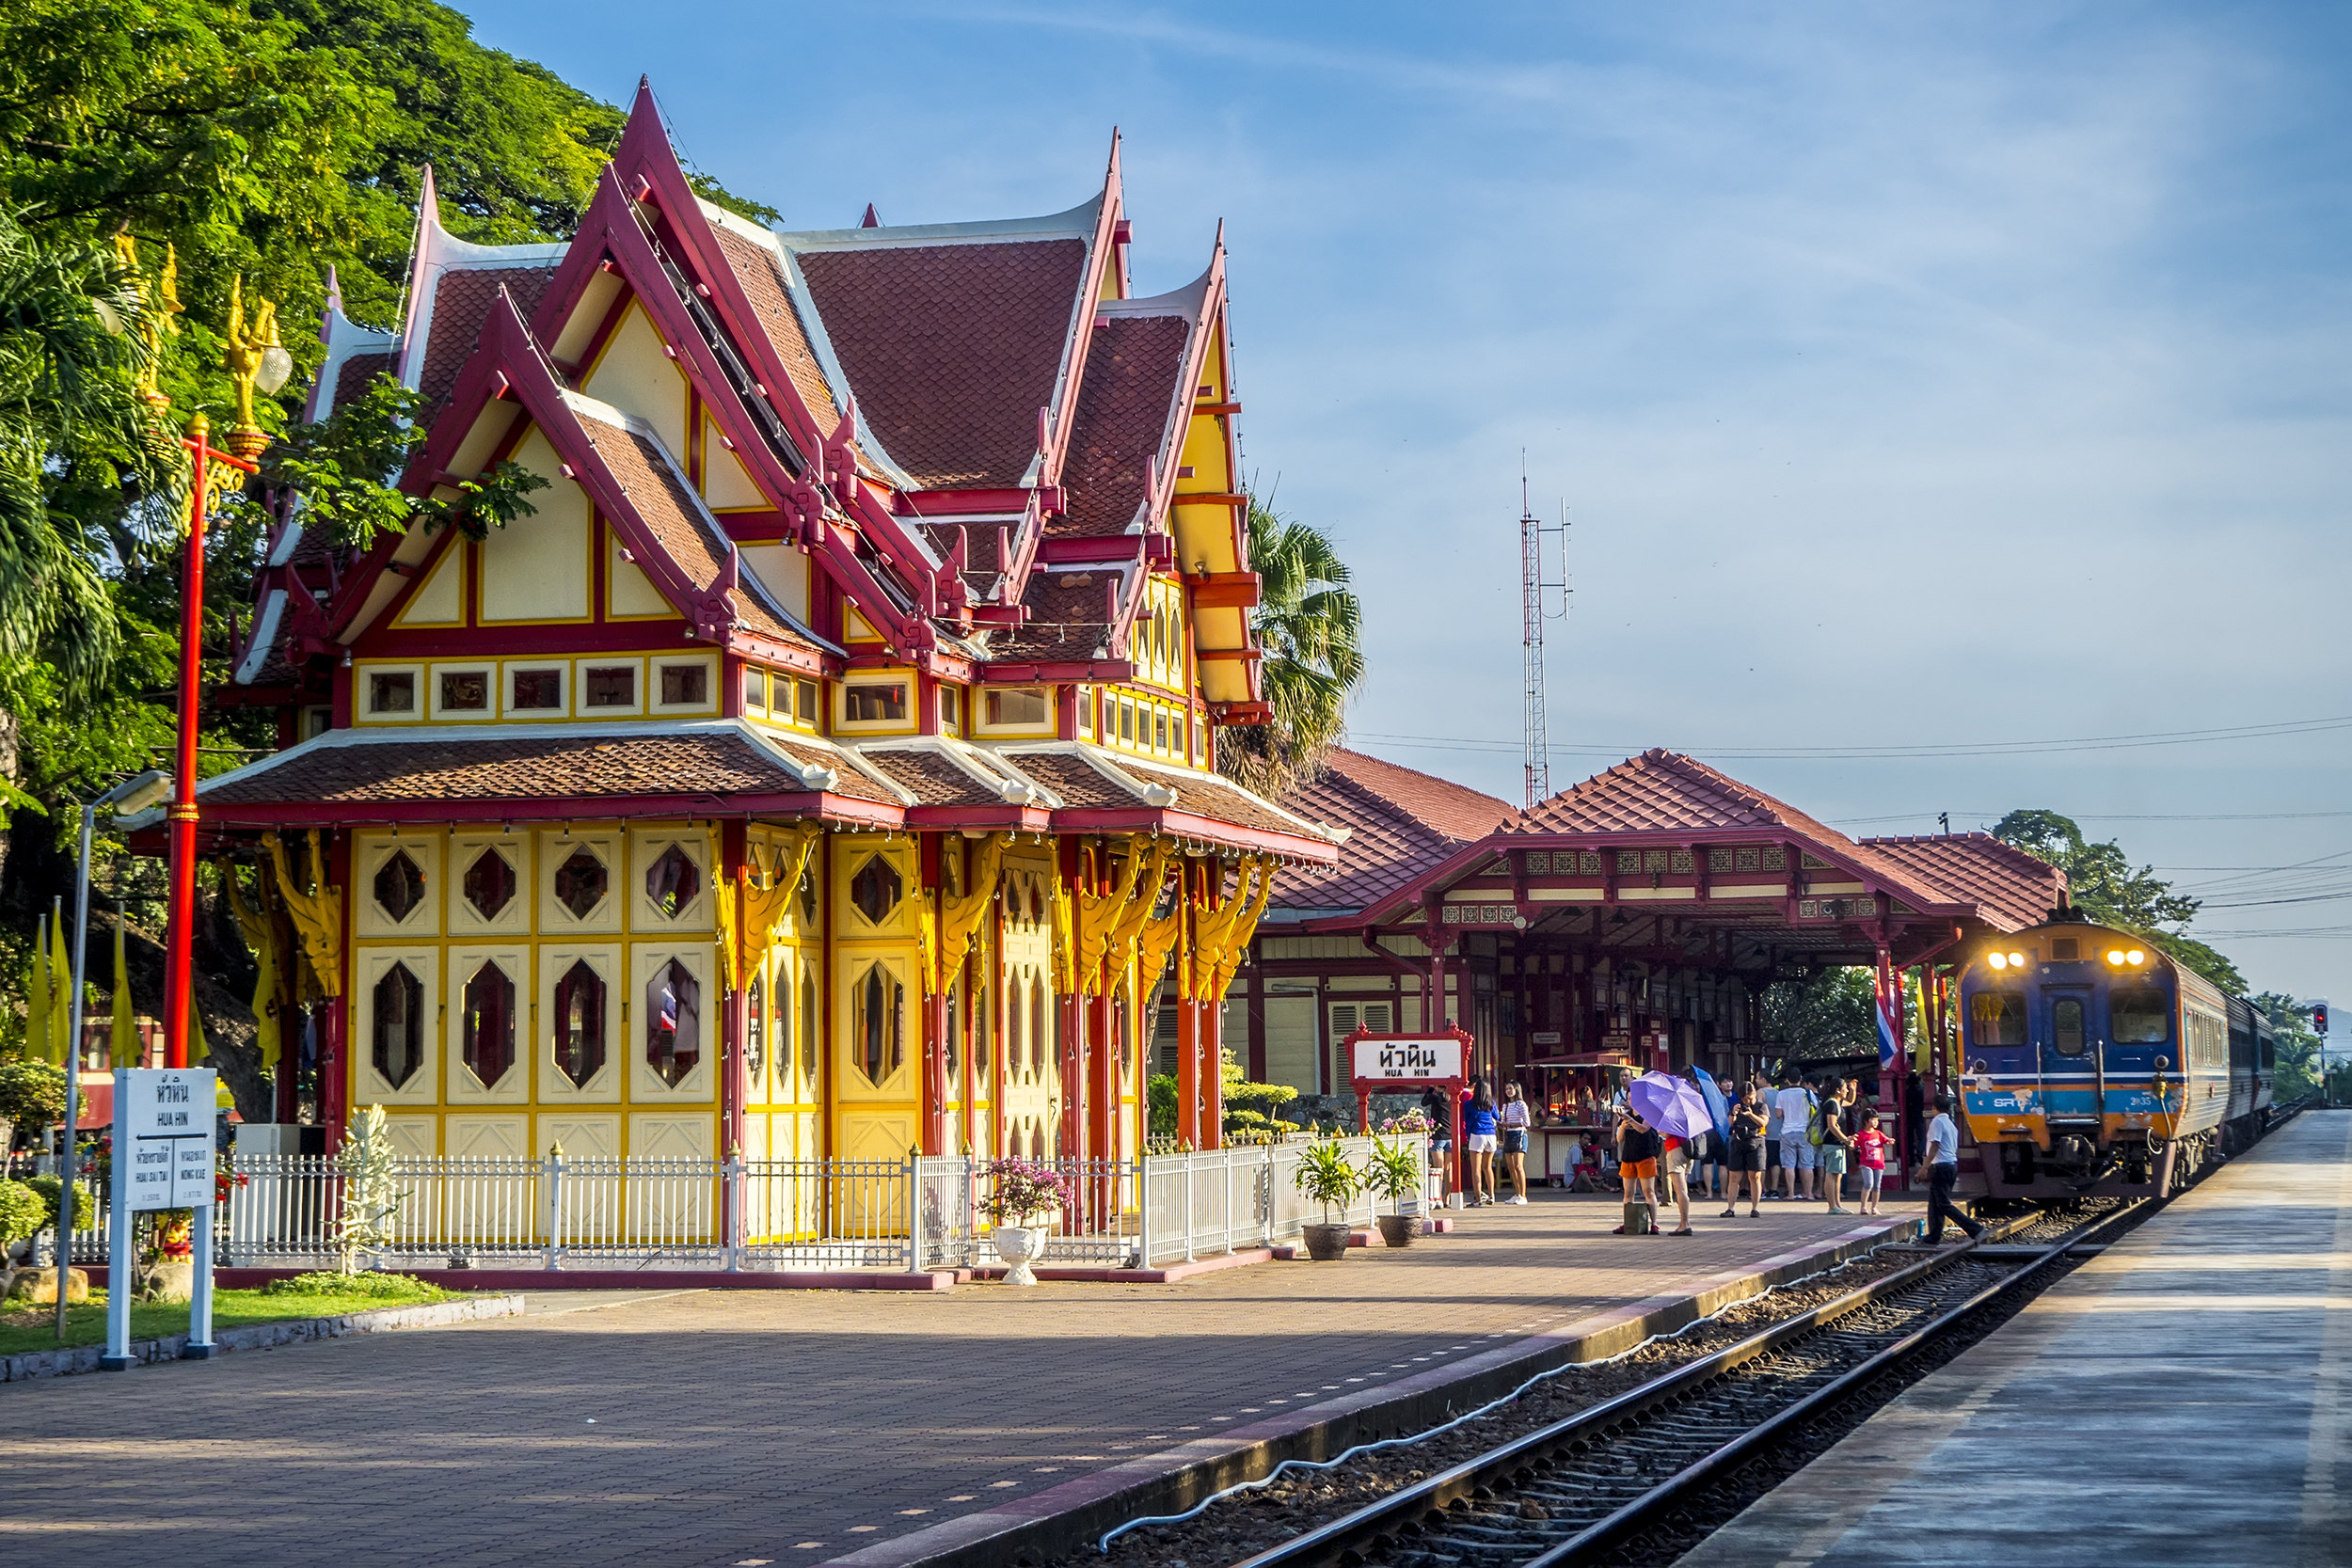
(73, 1135, 1433, 1272)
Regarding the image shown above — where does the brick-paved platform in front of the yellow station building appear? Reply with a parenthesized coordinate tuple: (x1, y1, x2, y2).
(0, 1195, 1917, 1568)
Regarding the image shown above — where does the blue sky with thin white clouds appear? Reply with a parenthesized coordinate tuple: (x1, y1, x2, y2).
(461, 0, 2352, 1020)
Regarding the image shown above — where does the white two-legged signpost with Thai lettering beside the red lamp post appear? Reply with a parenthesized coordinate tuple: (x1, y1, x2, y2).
(99, 1068, 219, 1373)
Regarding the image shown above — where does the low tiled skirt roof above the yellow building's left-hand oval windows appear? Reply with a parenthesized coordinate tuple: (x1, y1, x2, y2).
(202, 729, 807, 811)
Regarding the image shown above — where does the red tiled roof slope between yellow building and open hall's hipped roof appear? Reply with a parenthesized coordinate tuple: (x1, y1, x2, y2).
(1275, 750, 1515, 910)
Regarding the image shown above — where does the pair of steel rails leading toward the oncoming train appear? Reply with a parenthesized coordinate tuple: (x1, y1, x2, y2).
(1235, 1201, 2150, 1568)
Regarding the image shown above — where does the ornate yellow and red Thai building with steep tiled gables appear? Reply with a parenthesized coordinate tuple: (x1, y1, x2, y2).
(183, 89, 1339, 1162)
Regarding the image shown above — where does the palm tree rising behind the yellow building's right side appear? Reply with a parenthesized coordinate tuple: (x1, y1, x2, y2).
(1216, 496, 1364, 795)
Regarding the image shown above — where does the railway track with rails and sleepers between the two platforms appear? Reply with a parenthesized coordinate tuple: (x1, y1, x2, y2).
(1237, 1204, 2153, 1568)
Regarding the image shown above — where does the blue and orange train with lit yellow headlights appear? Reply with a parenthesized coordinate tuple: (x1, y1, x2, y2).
(1960, 908, 2277, 1204)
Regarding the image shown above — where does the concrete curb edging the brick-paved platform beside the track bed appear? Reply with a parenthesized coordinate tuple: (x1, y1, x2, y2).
(831, 1220, 1919, 1568)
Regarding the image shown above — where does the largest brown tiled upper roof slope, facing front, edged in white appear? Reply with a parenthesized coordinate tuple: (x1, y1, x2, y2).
(800, 237, 1087, 489)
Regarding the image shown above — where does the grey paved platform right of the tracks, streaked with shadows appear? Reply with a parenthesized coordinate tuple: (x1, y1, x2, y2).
(1682, 1112, 2352, 1568)
